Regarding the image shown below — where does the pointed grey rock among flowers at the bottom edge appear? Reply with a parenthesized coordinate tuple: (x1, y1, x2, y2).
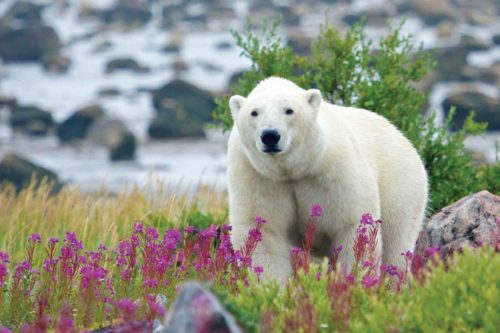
(161, 282, 243, 333)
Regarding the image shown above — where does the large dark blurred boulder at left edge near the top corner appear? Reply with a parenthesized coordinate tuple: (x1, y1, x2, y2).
(0, 24, 61, 62)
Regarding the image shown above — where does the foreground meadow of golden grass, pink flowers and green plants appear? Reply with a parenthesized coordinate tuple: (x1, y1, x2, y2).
(0, 184, 500, 333)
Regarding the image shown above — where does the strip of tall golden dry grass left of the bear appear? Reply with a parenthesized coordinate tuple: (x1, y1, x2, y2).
(0, 182, 227, 261)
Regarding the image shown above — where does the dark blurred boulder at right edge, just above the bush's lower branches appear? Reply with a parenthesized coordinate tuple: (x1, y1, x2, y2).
(442, 85, 500, 131)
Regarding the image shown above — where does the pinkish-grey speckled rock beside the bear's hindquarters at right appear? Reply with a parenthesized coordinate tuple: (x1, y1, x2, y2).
(415, 191, 500, 255)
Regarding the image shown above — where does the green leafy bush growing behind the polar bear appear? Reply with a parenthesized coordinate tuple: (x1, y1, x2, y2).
(213, 22, 500, 212)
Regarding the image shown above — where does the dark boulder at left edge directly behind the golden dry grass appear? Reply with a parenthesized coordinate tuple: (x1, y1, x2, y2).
(0, 153, 62, 191)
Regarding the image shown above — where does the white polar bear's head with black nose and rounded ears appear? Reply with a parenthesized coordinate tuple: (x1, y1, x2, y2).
(229, 78, 322, 179)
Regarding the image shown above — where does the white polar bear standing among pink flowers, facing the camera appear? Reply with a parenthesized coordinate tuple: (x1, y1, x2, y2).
(228, 77, 428, 280)
